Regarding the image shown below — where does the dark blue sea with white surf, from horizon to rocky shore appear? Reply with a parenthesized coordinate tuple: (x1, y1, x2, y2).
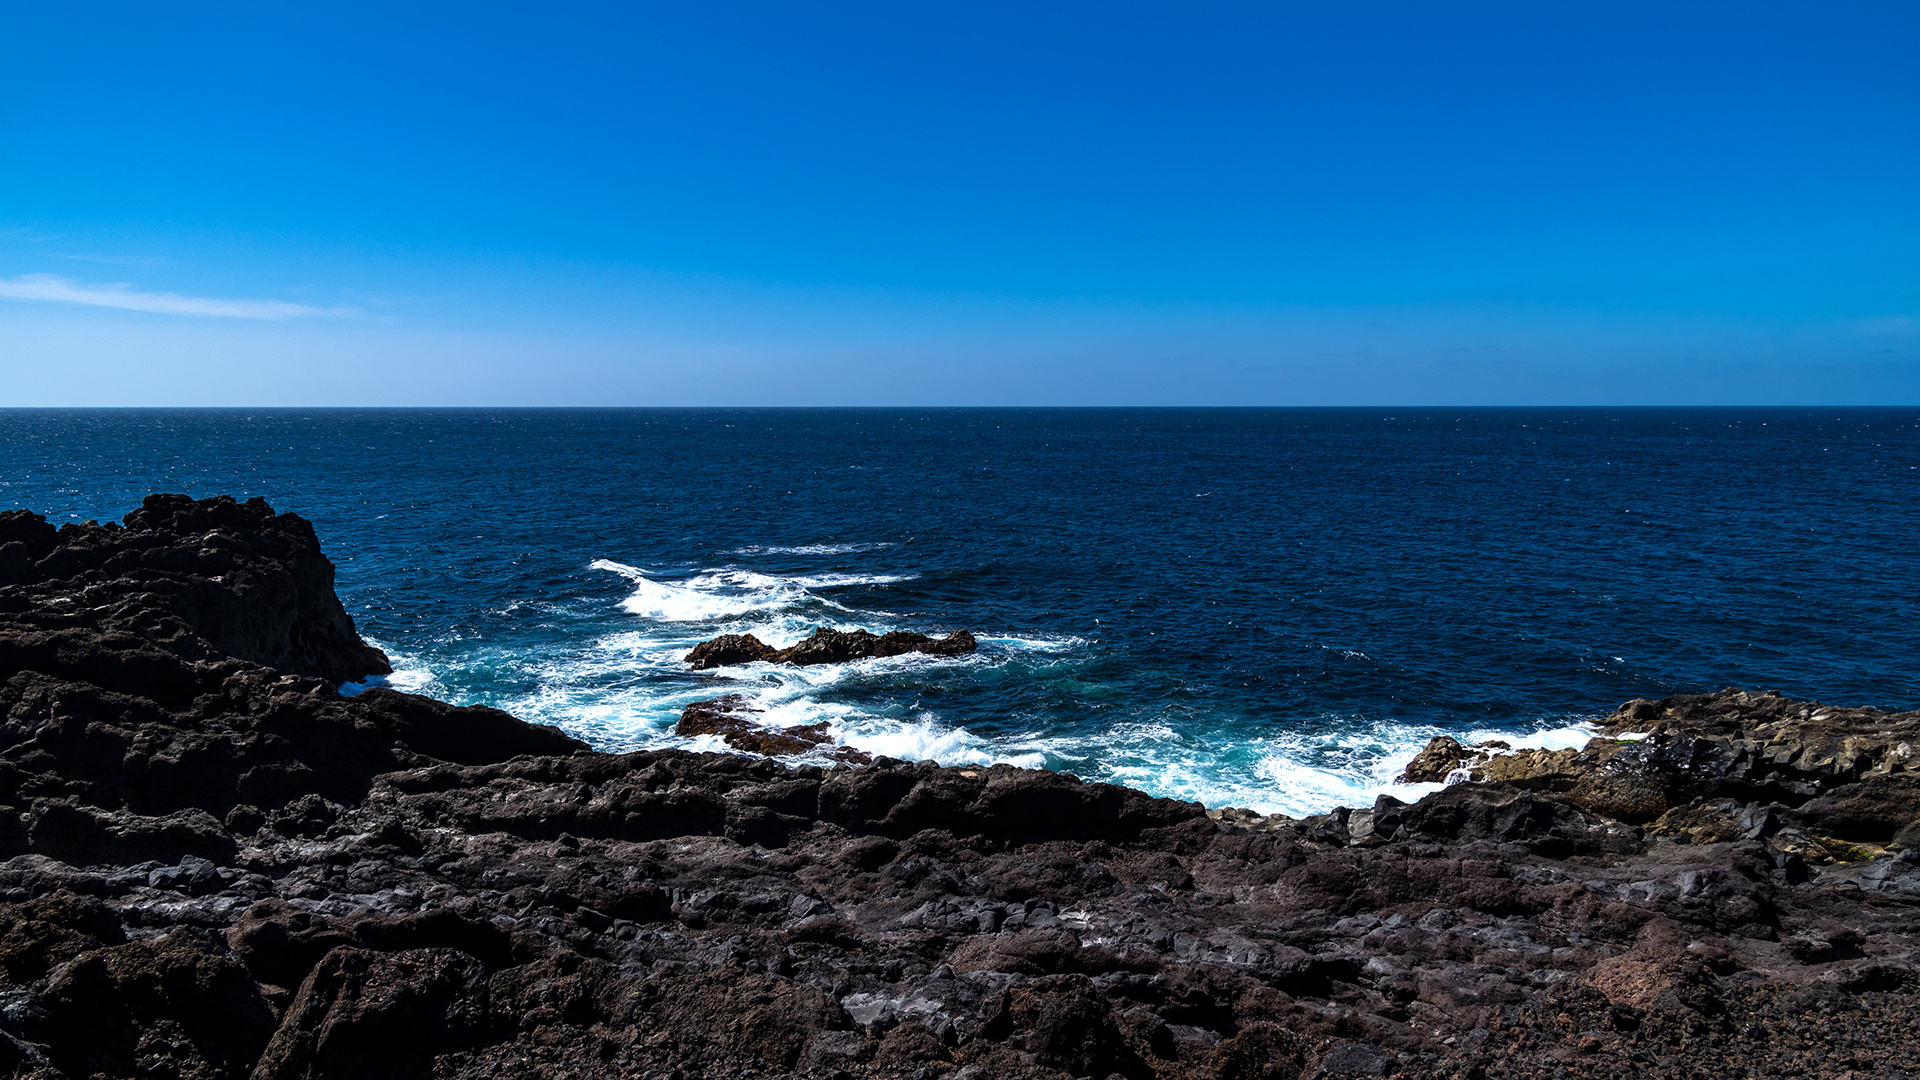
(0, 407, 1920, 813)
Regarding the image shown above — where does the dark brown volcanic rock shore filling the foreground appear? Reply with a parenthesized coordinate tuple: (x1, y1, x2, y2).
(0, 496, 1920, 1080)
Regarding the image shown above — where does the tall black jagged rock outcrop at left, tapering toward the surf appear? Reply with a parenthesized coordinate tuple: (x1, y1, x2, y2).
(0, 496, 586, 863)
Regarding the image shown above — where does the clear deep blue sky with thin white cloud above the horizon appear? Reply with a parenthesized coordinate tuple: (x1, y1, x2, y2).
(0, 0, 1920, 405)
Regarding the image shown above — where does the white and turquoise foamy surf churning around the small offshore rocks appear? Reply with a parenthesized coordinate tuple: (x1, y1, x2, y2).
(362, 559, 1620, 817)
